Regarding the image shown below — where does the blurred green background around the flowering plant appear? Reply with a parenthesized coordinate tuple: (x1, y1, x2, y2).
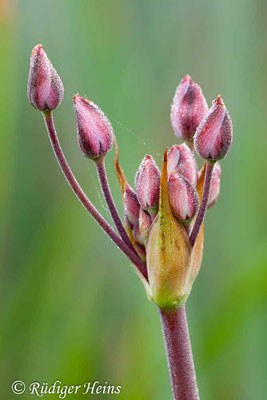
(0, 0, 267, 400)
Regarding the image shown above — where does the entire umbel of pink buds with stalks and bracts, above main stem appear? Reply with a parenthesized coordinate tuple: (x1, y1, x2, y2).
(28, 45, 232, 310)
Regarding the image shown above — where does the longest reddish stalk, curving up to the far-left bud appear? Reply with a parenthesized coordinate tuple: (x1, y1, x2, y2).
(43, 112, 148, 279)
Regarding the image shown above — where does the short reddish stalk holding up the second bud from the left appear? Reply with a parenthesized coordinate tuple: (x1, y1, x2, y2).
(96, 157, 135, 252)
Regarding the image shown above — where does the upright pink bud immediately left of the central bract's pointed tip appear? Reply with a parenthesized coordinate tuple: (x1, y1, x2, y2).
(135, 155, 160, 215)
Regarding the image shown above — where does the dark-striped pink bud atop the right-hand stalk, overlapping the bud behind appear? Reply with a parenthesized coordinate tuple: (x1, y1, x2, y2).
(194, 95, 233, 161)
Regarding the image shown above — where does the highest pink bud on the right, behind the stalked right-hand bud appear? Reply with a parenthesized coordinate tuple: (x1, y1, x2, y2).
(171, 75, 208, 140)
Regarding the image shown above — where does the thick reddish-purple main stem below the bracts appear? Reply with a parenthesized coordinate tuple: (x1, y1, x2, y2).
(159, 306, 199, 400)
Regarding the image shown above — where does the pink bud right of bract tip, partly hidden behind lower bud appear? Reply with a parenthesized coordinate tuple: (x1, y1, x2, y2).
(168, 143, 198, 187)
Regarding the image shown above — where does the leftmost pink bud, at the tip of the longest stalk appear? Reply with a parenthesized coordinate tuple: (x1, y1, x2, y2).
(28, 44, 64, 111)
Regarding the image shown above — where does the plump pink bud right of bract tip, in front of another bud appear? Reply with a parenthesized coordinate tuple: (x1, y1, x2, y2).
(168, 172, 199, 225)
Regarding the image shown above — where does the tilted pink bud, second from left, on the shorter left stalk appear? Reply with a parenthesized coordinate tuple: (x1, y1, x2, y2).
(73, 94, 113, 159)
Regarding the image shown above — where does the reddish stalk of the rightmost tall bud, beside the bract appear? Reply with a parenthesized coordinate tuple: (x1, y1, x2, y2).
(190, 161, 215, 247)
